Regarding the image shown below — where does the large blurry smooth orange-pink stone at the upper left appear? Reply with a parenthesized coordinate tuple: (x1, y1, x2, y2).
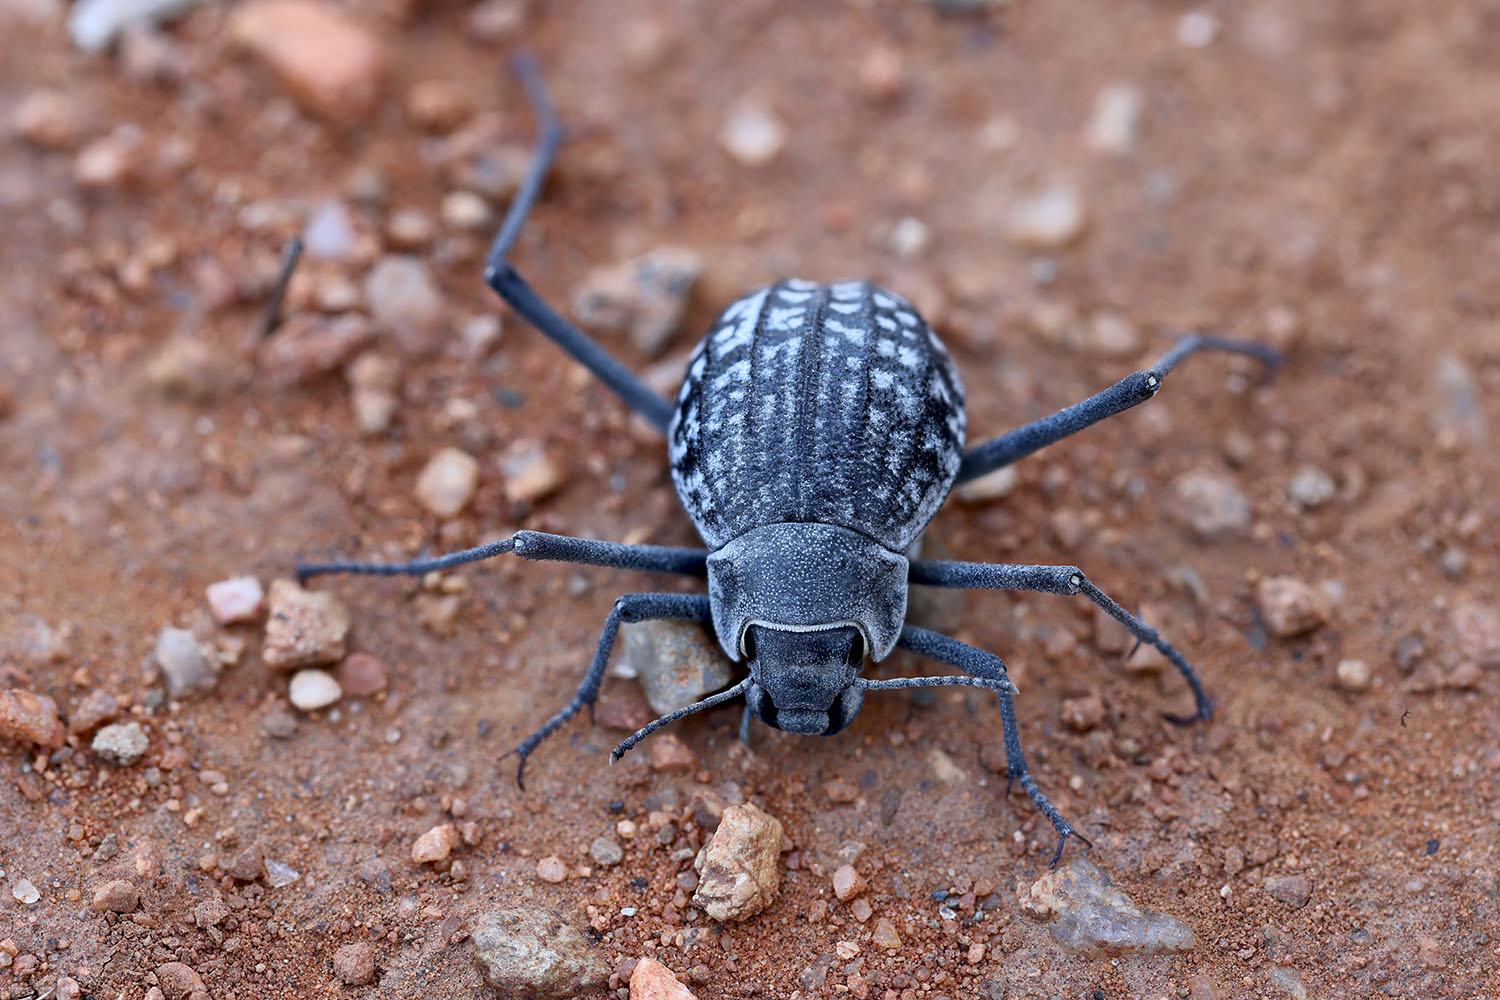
(230, 0, 386, 123)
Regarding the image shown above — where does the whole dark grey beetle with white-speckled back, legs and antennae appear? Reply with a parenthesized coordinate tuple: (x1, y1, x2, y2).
(297, 57, 1278, 865)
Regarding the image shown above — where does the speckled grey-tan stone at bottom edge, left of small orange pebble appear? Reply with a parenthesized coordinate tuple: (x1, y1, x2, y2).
(468, 906, 612, 1000)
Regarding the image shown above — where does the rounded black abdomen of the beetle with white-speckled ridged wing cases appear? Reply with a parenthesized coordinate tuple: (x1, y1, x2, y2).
(668, 280, 965, 552)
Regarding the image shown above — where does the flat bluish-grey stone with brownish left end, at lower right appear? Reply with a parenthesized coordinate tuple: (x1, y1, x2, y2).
(1020, 858, 1194, 954)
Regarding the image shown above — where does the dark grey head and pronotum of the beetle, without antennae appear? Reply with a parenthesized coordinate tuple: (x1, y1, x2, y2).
(708, 522, 908, 735)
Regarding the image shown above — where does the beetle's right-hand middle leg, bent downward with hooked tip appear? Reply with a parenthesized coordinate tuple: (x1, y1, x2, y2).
(908, 559, 1214, 726)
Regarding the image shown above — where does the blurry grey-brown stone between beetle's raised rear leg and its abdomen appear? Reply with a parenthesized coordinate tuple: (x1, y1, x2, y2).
(573, 246, 704, 357)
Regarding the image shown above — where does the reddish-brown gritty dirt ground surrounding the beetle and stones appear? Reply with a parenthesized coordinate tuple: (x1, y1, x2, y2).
(0, 0, 1500, 1000)
